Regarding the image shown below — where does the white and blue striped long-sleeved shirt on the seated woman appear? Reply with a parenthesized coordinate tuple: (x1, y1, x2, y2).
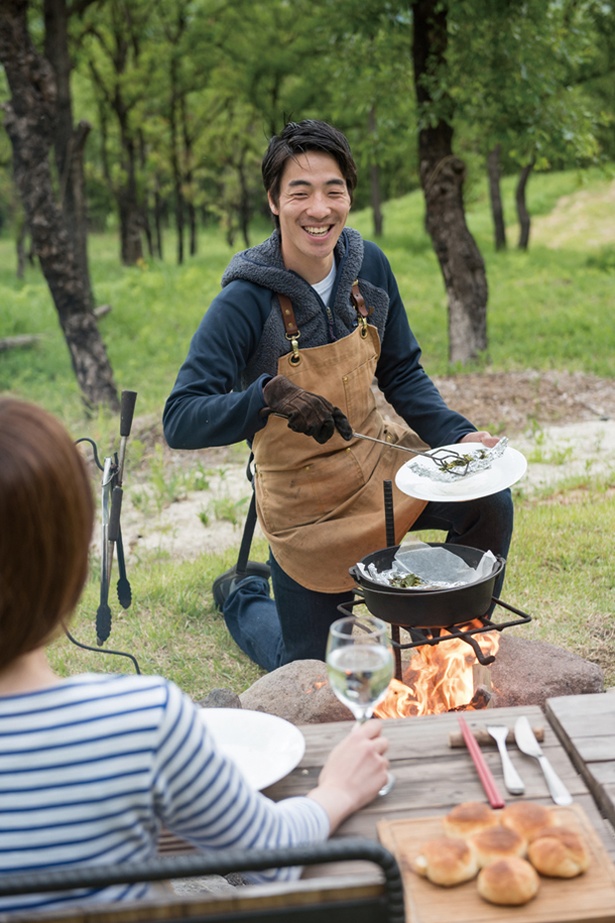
(0, 674, 329, 911)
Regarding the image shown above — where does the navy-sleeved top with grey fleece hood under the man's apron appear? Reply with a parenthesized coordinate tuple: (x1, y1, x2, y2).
(163, 228, 475, 449)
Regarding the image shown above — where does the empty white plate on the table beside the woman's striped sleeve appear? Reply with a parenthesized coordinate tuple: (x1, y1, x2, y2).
(200, 708, 305, 791)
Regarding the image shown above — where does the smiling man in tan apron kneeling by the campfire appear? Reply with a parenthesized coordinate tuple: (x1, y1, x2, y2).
(163, 119, 513, 670)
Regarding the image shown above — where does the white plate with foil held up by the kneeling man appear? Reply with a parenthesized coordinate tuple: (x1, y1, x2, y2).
(395, 442, 527, 503)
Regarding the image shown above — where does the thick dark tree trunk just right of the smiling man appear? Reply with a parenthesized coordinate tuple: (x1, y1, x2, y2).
(412, 0, 487, 364)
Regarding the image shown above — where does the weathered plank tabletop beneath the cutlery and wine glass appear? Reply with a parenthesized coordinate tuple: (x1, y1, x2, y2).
(266, 696, 615, 859)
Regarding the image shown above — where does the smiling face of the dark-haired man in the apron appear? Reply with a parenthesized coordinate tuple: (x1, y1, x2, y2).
(269, 151, 350, 284)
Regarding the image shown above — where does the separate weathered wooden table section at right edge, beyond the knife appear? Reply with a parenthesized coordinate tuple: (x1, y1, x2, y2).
(545, 693, 615, 825)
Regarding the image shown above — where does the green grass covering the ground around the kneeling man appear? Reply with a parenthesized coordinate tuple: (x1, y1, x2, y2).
(0, 171, 615, 699)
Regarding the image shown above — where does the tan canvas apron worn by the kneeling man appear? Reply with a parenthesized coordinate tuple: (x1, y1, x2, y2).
(253, 324, 426, 593)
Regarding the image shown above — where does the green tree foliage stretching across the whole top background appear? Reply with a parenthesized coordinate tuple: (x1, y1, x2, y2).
(0, 0, 615, 245)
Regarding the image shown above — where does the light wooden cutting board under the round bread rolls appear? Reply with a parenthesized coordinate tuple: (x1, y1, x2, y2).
(378, 804, 615, 923)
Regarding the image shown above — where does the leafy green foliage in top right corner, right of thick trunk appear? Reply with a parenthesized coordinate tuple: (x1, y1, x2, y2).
(448, 0, 612, 169)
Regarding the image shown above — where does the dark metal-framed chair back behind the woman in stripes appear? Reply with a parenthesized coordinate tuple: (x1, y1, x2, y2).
(0, 837, 405, 923)
